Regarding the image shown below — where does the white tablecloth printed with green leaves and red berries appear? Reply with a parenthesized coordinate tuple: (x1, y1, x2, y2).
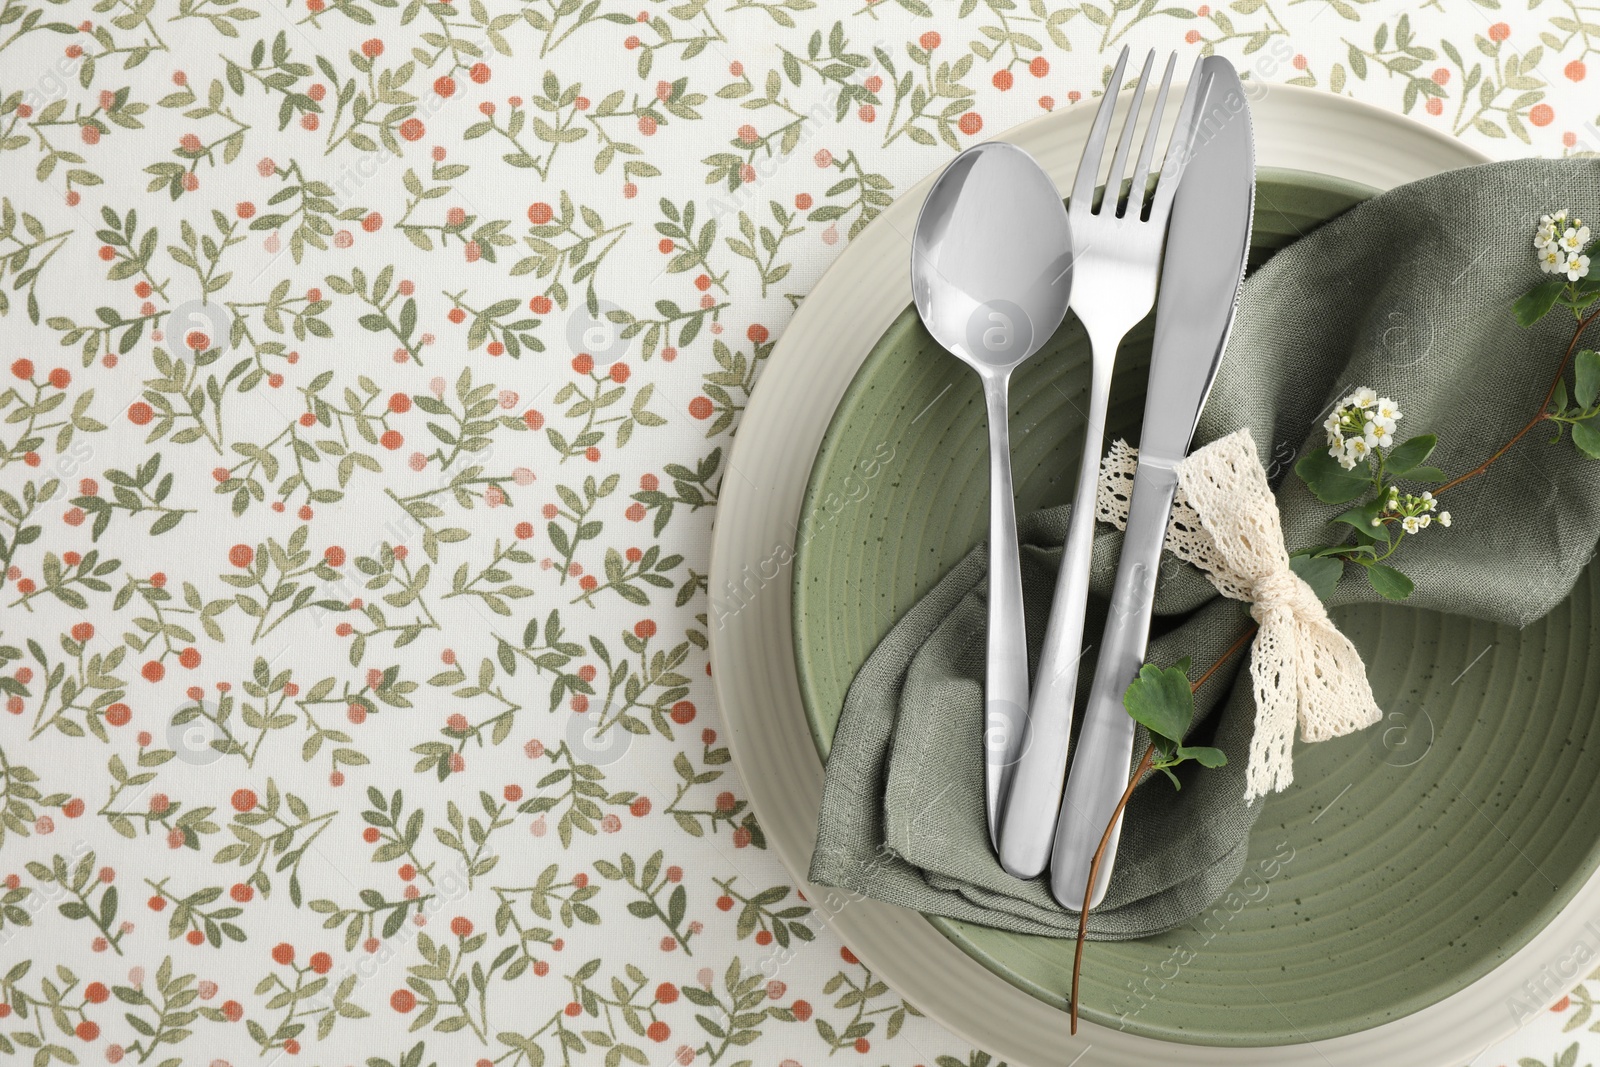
(0, 0, 1600, 1067)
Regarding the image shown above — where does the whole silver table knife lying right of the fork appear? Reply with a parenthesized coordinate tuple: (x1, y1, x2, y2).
(1050, 56, 1256, 910)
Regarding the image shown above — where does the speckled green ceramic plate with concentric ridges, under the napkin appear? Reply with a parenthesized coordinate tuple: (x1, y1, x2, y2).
(794, 171, 1600, 1046)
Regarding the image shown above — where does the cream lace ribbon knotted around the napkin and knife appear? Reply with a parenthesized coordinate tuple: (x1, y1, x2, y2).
(1094, 429, 1382, 801)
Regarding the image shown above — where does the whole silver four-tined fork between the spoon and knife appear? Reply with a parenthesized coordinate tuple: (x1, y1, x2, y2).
(1000, 48, 1200, 878)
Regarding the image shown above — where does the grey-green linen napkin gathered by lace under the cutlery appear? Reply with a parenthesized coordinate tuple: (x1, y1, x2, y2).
(810, 160, 1600, 941)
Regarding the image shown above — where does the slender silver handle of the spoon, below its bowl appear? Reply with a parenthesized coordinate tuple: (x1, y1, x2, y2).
(984, 373, 1027, 848)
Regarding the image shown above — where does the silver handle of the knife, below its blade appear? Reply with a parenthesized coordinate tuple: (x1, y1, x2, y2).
(1050, 456, 1178, 912)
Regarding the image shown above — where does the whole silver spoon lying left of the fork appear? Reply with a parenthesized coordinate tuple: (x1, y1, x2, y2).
(910, 141, 1072, 848)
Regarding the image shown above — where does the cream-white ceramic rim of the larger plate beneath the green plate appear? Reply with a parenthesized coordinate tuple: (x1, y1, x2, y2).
(710, 83, 1561, 1067)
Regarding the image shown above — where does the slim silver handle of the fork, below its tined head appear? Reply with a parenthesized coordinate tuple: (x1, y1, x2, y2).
(998, 355, 1117, 878)
